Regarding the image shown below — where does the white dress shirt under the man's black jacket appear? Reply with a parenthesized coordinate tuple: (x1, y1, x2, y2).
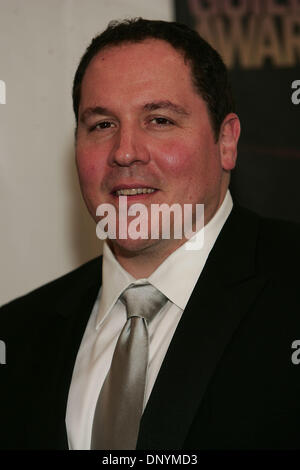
(66, 191, 232, 450)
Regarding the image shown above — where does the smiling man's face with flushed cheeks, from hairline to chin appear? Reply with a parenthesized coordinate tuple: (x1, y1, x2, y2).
(76, 39, 239, 255)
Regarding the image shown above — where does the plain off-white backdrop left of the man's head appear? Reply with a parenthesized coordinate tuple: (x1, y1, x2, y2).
(0, 0, 174, 305)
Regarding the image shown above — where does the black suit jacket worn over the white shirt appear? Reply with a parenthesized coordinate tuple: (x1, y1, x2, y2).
(0, 208, 300, 449)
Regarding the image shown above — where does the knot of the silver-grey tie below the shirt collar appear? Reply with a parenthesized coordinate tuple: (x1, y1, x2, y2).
(120, 284, 168, 323)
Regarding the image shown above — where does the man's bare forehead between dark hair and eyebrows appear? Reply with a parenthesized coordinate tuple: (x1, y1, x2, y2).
(81, 39, 199, 110)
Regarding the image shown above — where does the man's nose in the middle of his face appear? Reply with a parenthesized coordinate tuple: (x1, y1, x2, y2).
(111, 124, 149, 166)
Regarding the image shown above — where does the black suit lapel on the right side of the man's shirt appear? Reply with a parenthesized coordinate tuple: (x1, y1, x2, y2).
(137, 209, 265, 449)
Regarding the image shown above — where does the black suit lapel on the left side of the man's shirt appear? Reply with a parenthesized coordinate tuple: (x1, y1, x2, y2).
(27, 258, 102, 449)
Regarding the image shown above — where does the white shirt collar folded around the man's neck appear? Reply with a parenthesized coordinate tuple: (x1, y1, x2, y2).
(96, 191, 233, 328)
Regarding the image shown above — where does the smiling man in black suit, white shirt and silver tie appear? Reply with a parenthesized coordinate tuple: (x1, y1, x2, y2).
(0, 19, 300, 449)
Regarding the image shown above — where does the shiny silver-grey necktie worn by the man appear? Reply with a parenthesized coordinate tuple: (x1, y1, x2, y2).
(91, 283, 167, 450)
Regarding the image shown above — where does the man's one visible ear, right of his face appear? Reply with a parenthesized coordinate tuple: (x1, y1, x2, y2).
(219, 113, 241, 171)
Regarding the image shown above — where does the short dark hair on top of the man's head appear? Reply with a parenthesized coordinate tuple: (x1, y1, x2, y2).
(73, 18, 234, 140)
